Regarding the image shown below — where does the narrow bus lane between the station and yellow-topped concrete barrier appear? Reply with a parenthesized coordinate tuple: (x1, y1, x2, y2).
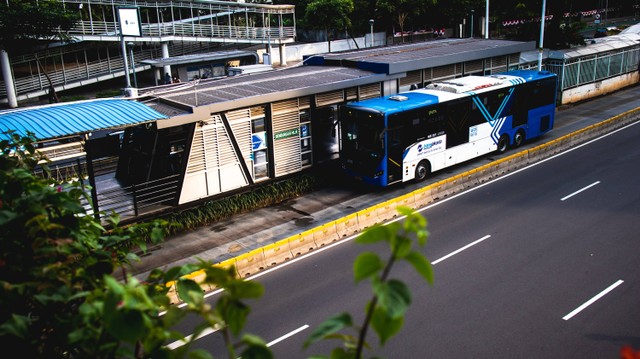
(125, 86, 640, 279)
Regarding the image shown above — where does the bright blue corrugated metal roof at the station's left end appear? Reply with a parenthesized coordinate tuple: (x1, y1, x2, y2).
(0, 98, 167, 141)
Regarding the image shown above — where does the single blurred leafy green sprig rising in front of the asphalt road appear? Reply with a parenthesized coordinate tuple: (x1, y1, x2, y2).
(304, 207, 433, 359)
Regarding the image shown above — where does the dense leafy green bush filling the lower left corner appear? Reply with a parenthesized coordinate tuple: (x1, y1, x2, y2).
(0, 134, 268, 358)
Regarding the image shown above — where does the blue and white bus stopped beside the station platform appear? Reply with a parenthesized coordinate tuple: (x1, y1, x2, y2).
(340, 70, 557, 186)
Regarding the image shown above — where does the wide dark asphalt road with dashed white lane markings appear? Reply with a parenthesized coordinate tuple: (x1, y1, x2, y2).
(172, 115, 640, 359)
